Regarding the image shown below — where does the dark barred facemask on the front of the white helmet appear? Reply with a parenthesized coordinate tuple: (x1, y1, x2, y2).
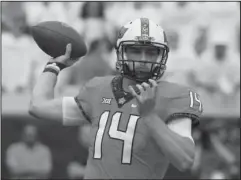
(116, 41, 169, 83)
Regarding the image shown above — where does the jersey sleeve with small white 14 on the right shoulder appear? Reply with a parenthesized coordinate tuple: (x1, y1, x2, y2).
(164, 90, 203, 126)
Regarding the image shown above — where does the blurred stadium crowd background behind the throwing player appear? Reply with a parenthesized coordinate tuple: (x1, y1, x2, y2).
(1, 2, 240, 179)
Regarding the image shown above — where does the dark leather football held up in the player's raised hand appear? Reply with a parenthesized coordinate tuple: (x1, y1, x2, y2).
(31, 21, 87, 58)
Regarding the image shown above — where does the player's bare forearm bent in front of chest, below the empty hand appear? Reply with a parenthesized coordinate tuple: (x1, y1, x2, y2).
(145, 115, 195, 171)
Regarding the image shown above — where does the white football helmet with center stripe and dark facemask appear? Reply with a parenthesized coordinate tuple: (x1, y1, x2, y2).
(115, 18, 169, 82)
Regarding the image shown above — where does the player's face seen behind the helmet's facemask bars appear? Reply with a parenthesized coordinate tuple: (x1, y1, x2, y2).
(125, 45, 161, 72)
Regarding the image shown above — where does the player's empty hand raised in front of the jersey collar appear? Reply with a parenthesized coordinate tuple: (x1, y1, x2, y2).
(129, 79, 157, 116)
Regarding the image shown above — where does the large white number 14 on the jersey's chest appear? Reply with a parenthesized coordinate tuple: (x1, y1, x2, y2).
(94, 111, 140, 164)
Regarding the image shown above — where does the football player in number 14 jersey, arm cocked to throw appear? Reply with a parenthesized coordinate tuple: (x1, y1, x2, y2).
(29, 18, 203, 179)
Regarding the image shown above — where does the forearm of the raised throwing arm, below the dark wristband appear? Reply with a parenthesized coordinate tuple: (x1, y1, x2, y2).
(31, 72, 57, 103)
